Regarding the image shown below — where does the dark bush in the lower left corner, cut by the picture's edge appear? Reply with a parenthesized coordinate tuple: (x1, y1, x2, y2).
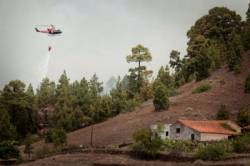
(0, 141, 20, 159)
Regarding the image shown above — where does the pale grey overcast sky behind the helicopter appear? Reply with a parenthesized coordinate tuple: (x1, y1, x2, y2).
(0, 0, 249, 87)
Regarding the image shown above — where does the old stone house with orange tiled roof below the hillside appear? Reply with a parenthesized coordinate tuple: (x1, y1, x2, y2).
(151, 120, 241, 141)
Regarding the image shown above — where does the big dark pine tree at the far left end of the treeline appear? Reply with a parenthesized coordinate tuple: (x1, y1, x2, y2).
(2, 80, 36, 138)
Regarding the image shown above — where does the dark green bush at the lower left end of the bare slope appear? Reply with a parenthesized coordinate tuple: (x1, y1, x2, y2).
(45, 128, 67, 147)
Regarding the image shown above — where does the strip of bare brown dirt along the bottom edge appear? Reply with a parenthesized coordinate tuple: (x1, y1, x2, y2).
(21, 153, 250, 166)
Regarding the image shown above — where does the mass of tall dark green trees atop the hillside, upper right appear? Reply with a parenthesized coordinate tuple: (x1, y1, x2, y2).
(166, 7, 244, 83)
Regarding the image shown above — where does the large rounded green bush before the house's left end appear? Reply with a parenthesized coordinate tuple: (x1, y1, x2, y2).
(131, 128, 163, 159)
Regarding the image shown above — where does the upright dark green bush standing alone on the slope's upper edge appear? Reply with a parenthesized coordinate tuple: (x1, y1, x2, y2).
(153, 82, 169, 111)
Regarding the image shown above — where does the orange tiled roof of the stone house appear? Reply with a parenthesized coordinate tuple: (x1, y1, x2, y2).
(179, 120, 239, 135)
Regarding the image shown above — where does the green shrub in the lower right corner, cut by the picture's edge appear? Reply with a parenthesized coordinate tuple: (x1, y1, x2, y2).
(233, 134, 250, 153)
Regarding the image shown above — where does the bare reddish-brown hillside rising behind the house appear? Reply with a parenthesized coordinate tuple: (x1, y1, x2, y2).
(30, 52, 250, 150)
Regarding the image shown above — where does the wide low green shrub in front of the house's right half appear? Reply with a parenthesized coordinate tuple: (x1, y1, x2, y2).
(195, 142, 231, 160)
